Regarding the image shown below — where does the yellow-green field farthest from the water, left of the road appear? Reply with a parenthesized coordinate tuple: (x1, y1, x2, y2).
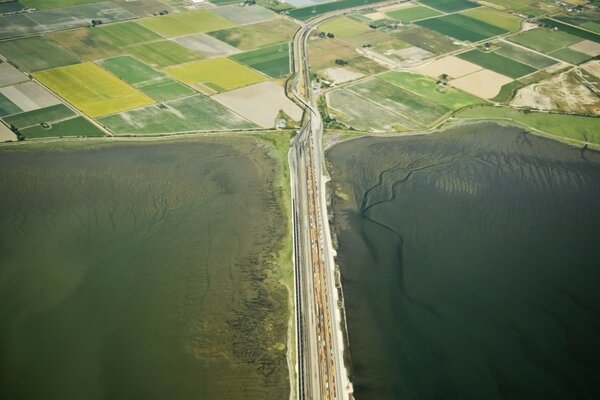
(139, 10, 235, 37)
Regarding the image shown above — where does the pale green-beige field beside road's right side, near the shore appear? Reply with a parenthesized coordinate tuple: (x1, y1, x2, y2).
(326, 89, 406, 132)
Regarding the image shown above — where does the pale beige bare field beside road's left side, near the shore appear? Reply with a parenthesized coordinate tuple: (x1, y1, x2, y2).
(212, 82, 302, 128)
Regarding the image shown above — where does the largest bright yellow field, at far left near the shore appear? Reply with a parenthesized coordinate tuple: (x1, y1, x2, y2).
(33, 62, 154, 117)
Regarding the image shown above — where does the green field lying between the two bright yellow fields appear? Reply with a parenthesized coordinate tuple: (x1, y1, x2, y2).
(100, 56, 194, 101)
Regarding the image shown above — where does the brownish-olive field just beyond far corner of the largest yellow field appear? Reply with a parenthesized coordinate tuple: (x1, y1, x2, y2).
(46, 28, 122, 61)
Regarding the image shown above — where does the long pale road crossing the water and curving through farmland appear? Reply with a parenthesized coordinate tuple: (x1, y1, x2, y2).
(288, 0, 407, 400)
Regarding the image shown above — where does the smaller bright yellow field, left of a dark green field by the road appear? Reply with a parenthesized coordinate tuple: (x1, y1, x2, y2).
(165, 58, 268, 92)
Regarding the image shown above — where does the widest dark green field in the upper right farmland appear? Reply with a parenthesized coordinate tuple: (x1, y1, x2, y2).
(416, 14, 508, 42)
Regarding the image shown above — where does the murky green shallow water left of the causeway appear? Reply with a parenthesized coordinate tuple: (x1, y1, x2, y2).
(0, 138, 289, 400)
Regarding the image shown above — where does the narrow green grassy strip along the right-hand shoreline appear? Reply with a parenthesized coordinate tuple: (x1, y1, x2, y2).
(457, 107, 600, 144)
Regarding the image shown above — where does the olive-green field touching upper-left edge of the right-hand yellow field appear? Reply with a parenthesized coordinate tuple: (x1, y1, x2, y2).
(127, 40, 200, 67)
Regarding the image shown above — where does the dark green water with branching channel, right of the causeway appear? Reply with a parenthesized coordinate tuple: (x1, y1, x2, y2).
(328, 124, 600, 400)
